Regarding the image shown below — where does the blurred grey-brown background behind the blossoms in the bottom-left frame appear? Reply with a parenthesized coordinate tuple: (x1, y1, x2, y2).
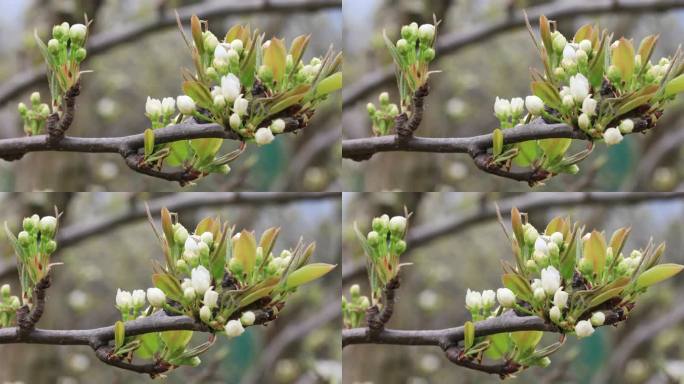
(0, 193, 342, 384)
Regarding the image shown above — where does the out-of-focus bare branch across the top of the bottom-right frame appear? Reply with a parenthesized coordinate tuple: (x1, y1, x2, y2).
(342, 192, 684, 282)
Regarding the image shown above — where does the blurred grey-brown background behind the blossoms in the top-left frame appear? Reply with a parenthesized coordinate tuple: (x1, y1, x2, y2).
(0, 0, 342, 192)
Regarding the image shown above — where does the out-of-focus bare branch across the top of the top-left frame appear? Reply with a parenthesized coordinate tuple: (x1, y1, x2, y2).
(0, 0, 342, 106)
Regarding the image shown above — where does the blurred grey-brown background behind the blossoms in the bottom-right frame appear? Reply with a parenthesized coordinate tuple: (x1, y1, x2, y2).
(342, 193, 684, 384)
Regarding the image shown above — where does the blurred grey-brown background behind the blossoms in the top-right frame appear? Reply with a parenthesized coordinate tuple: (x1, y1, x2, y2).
(342, 0, 684, 191)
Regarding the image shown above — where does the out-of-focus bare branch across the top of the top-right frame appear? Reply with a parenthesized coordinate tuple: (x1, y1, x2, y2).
(342, 0, 684, 108)
